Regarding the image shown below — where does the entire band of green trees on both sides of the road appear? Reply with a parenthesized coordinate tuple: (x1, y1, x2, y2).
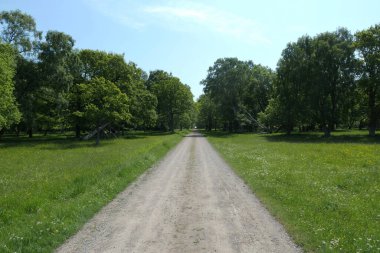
(0, 10, 380, 138)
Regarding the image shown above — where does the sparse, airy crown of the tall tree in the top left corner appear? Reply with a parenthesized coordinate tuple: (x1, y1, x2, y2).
(0, 10, 42, 54)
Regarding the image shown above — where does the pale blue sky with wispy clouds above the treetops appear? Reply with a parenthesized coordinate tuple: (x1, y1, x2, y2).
(0, 0, 380, 98)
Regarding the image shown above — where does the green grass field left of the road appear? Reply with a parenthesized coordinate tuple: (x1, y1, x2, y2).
(0, 133, 186, 252)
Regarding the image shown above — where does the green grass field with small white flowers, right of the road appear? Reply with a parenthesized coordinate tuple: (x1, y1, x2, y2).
(208, 131, 380, 252)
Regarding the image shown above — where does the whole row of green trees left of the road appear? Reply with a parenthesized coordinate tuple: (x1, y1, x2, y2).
(0, 10, 195, 142)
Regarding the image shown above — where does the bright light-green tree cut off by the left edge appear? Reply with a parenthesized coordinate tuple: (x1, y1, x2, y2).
(0, 43, 21, 136)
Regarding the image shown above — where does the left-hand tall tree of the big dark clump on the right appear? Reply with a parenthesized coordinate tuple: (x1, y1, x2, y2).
(272, 36, 312, 134)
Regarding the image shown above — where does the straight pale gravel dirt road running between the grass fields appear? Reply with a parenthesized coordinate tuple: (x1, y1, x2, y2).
(57, 133, 300, 253)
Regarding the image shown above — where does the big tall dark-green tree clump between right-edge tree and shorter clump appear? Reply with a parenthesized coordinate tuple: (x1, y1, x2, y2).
(261, 28, 358, 136)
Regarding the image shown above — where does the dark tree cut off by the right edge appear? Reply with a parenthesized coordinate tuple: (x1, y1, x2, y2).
(355, 25, 380, 136)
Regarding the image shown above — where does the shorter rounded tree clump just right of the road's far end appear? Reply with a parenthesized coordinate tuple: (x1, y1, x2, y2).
(200, 58, 275, 131)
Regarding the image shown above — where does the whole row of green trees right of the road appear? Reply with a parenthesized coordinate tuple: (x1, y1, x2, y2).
(197, 25, 380, 137)
